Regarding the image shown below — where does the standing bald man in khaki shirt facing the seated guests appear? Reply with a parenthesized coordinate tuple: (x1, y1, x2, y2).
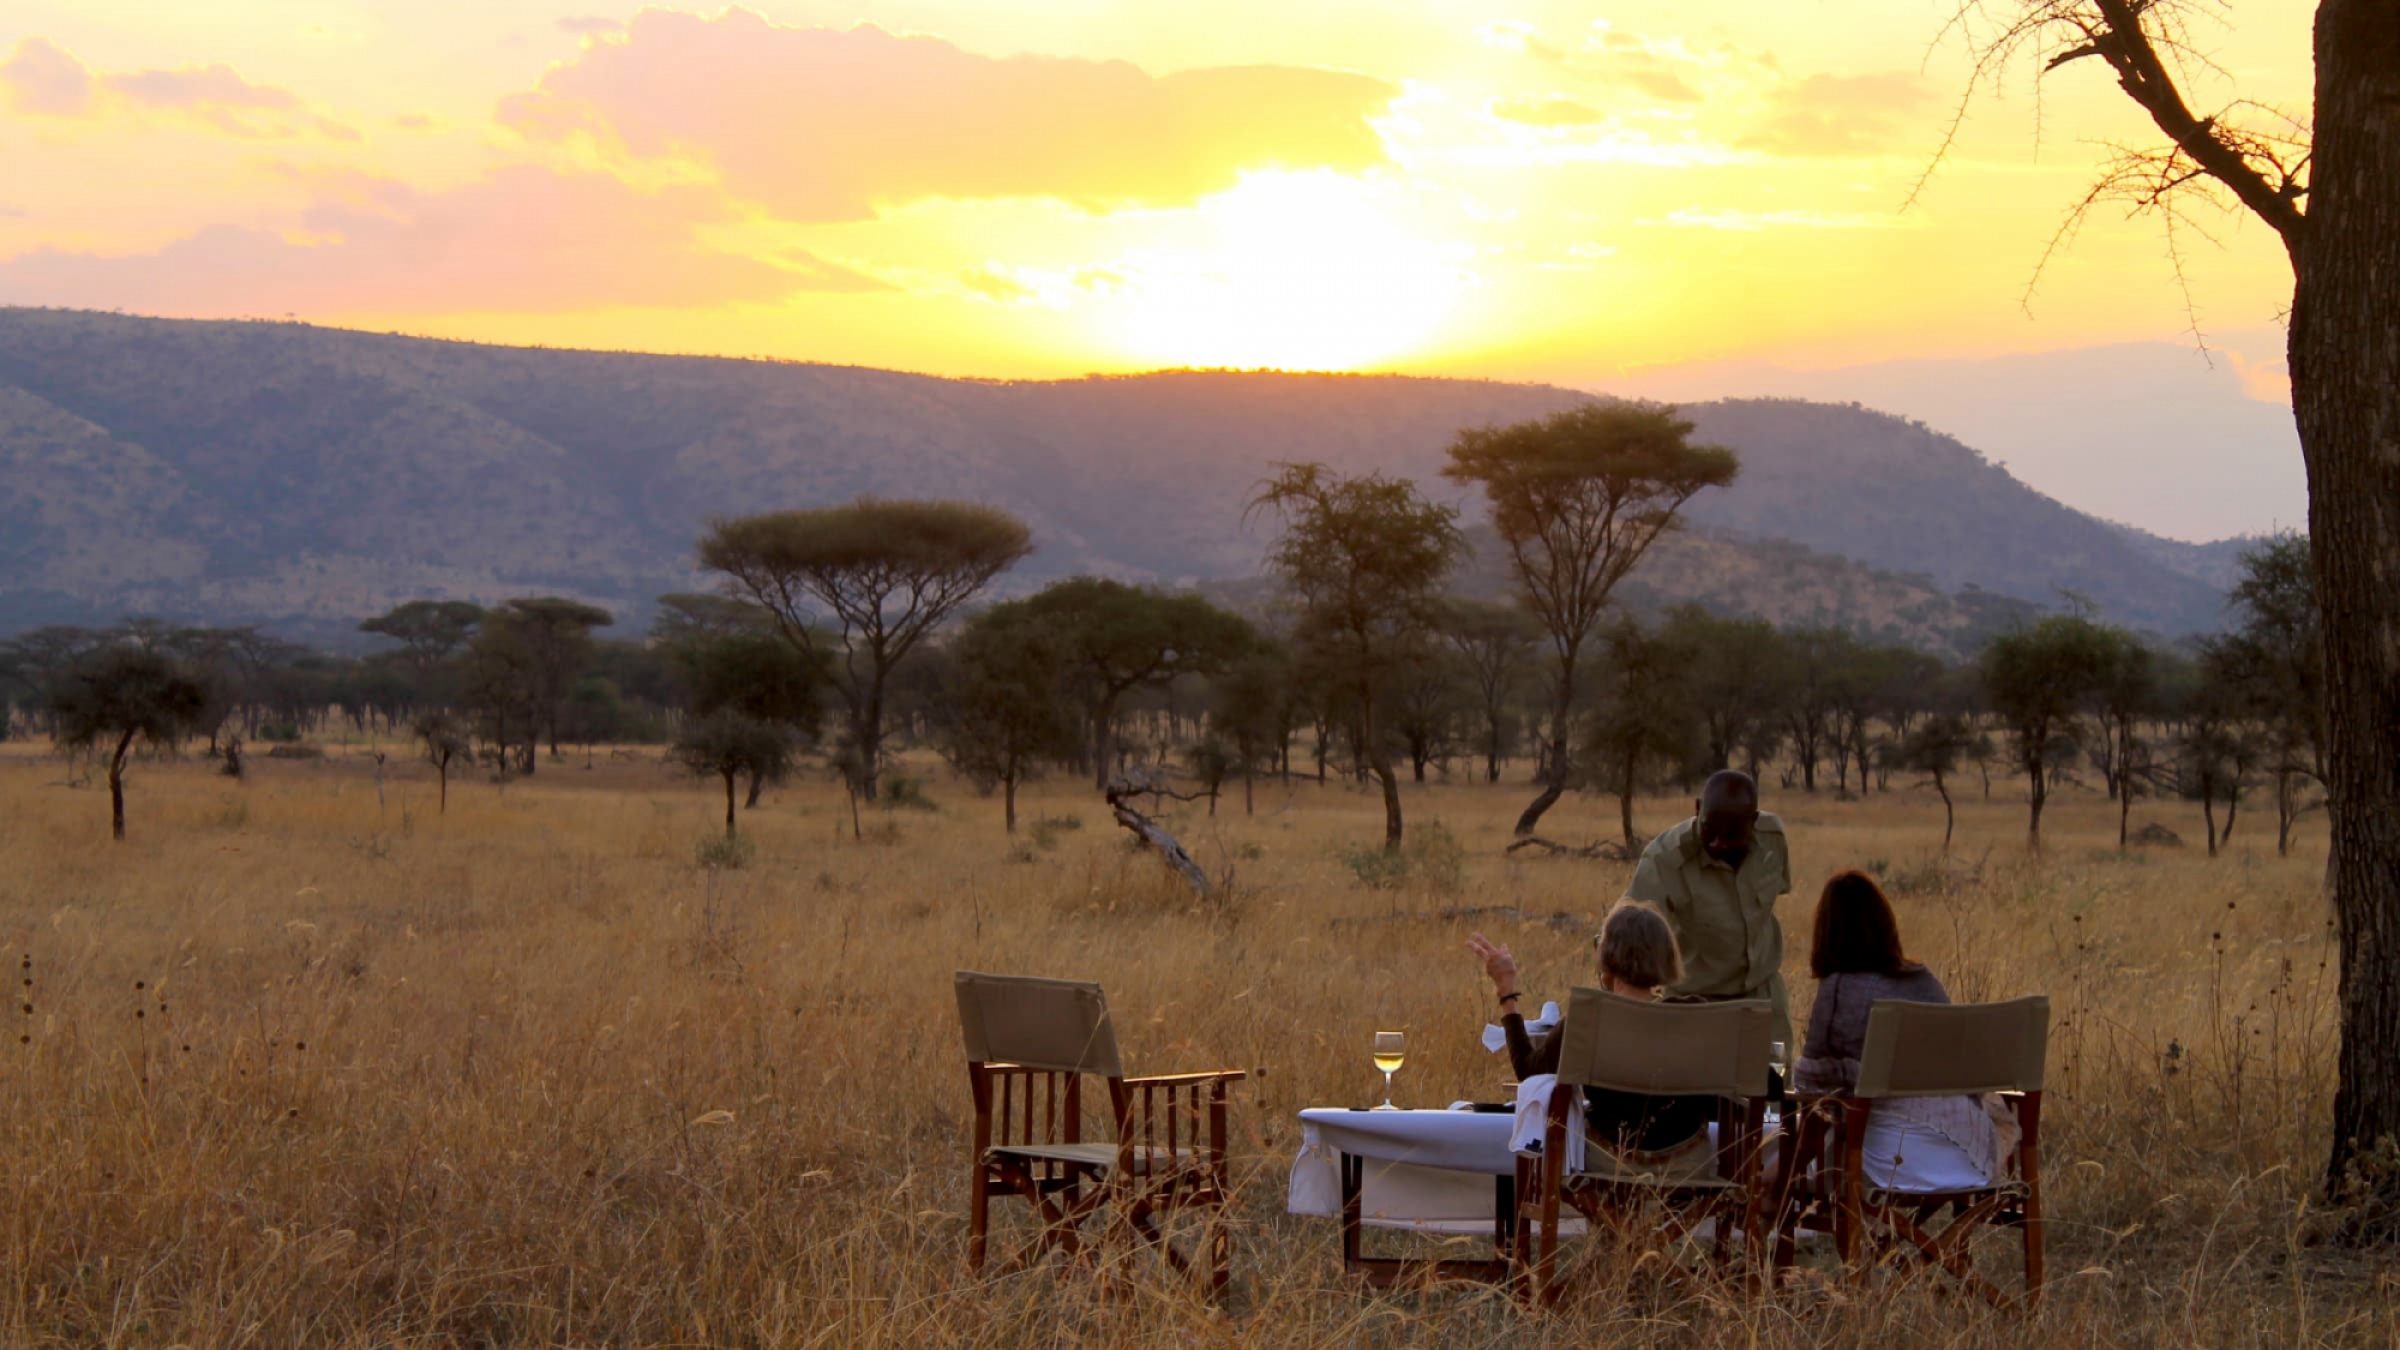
(1625, 769, 1793, 1050)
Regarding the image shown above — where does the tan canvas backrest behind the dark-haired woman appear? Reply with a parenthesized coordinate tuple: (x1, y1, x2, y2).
(1858, 994, 2050, 1098)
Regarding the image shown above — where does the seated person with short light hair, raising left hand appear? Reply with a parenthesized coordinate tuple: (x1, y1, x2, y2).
(1466, 901, 1716, 1153)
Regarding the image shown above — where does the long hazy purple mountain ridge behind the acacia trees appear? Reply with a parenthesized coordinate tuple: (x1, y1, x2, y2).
(0, 310, 2218, 646)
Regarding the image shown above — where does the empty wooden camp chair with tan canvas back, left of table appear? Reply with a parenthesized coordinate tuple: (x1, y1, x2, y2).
(958, 970, 1246, 1292)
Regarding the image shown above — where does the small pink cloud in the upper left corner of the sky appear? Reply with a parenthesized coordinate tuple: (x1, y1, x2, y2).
(0, 38, 358, 139)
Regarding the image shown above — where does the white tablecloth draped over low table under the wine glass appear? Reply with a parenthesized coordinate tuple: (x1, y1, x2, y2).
(1286, 1107, 1517, 1232)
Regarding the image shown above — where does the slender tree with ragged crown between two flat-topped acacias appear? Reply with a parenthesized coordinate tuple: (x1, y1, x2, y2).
(1250, 464, 1466, 853)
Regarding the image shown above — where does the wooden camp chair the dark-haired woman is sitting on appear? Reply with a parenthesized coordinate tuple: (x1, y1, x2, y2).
(1776, 997, 2050, 1304)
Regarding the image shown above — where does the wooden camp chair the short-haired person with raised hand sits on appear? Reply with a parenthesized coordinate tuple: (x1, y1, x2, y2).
(1510, 990, 1776, 1304)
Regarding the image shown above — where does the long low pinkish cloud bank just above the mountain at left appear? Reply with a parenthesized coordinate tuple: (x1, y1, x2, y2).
(0, 166, 881, 315)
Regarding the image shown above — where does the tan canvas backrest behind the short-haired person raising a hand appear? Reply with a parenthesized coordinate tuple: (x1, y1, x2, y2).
(1558, 990, 1776, 1098)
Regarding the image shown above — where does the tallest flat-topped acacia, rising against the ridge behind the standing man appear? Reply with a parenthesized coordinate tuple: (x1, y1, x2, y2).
(1442, 404, 1740, 836)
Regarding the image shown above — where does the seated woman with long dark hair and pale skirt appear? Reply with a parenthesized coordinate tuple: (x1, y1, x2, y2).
(1793, 872, 2004, 1191)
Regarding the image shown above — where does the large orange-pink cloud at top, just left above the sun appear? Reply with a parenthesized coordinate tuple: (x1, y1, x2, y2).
(502, 10, 1399, 221)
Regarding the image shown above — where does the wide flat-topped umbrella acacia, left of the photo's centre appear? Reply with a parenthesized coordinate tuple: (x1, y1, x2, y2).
(701, 497, 1032, 802)
